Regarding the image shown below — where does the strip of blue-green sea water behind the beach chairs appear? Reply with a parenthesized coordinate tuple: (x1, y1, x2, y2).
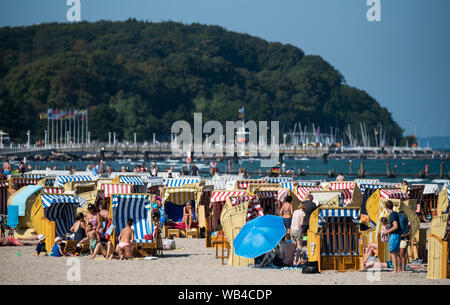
(17, 159, 450, 183)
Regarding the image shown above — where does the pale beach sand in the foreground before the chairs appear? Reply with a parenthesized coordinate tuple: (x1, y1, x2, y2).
(0, 239, 450, 285)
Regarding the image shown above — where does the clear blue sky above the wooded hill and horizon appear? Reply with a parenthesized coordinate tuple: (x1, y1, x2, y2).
(0, 0, 450, 137)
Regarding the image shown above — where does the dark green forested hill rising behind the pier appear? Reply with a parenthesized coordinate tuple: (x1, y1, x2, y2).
(0, 20, 402, 142)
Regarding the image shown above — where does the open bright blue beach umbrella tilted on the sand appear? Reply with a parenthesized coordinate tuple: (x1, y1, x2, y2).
(234, 215, 286, 258)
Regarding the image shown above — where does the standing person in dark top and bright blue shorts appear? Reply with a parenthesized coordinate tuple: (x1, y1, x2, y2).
(385, 200, 401, 273)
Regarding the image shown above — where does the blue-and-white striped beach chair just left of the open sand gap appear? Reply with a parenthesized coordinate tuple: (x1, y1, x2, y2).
(111, 194, 162, 256)
